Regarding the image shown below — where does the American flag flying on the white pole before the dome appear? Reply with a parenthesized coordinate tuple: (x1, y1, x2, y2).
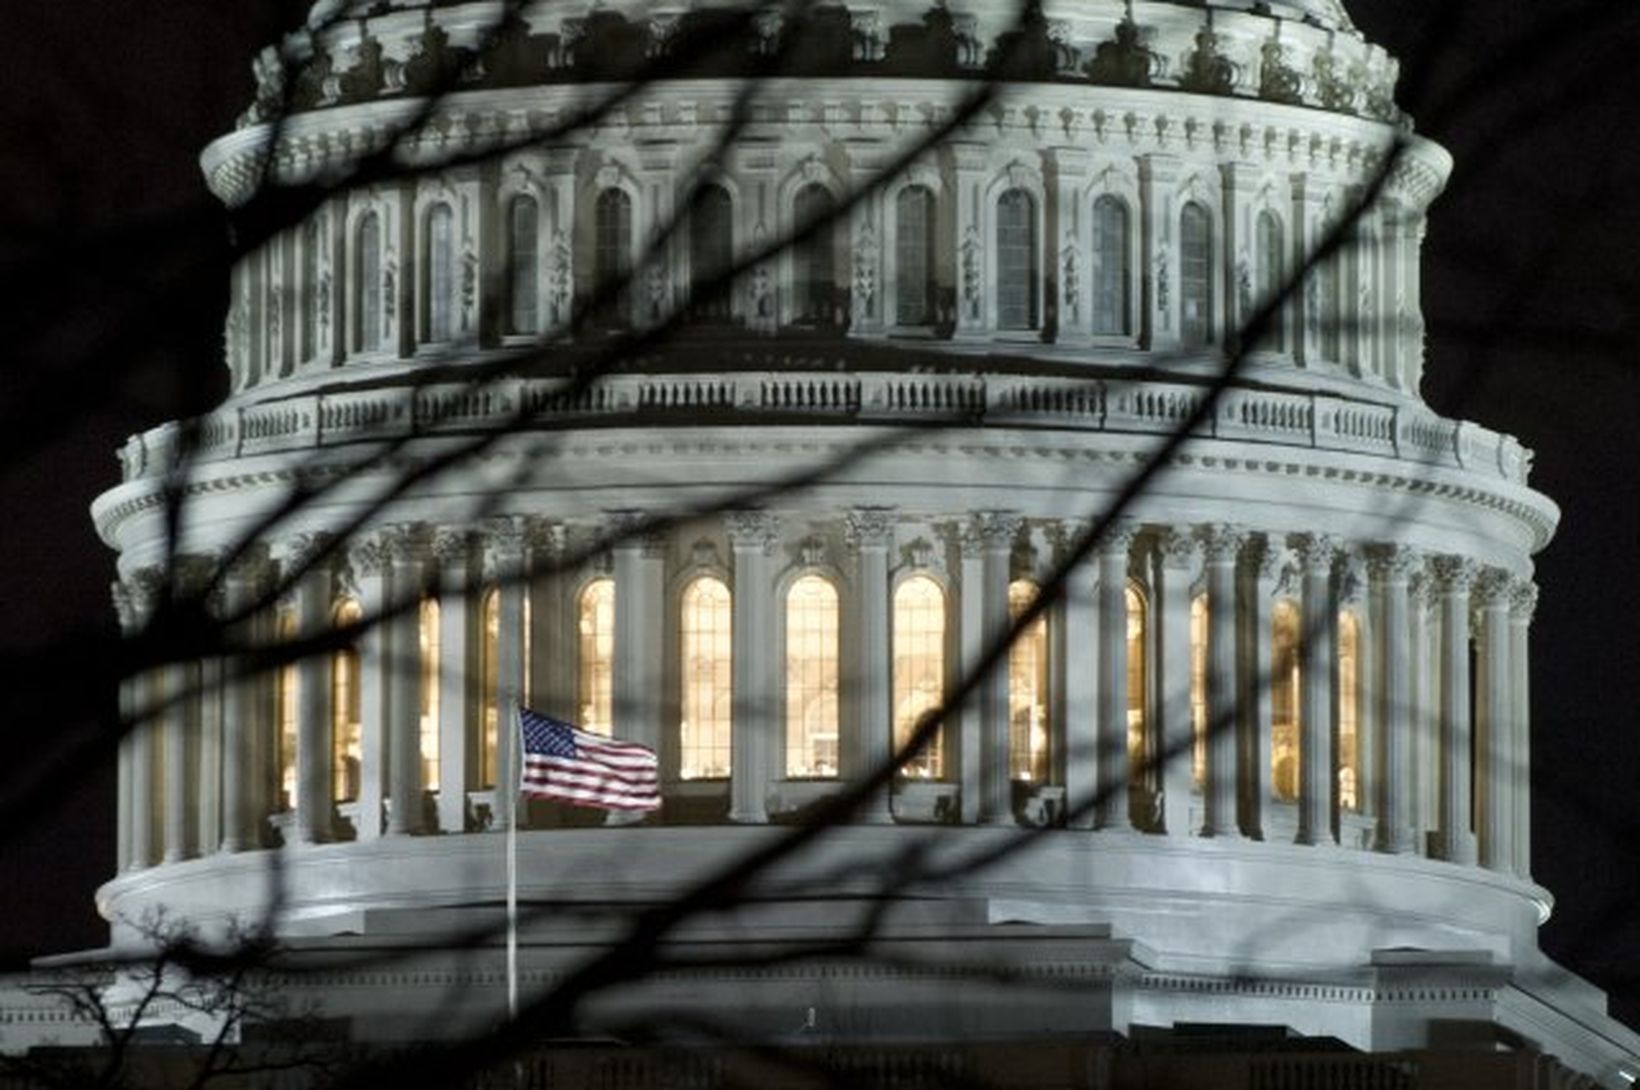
(518, 708, 661, 810)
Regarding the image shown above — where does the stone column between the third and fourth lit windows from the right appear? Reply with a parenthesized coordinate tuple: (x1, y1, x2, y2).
(1153, 526, 1196, 836)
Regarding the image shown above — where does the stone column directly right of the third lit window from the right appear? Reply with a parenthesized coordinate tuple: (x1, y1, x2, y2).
(1200, 523, 1246, 836)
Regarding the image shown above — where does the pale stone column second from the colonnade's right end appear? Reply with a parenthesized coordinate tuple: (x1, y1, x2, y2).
(1474, 567, 1515, 870)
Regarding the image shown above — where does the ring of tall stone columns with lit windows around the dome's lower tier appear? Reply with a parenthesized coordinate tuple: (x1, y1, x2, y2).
(115, 508, 1535, 877)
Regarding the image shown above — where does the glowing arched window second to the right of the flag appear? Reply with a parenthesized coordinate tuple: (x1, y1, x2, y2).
(786, 575, 838, 777)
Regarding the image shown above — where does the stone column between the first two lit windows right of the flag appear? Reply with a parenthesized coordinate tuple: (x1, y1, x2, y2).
(731, 511, 779, 824)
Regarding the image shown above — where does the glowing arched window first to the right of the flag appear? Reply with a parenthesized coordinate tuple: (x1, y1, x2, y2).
(677, 575, 735, 780)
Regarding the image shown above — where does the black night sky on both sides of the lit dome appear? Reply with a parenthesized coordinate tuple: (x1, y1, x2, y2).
(0, 0, 1640, 1024)
